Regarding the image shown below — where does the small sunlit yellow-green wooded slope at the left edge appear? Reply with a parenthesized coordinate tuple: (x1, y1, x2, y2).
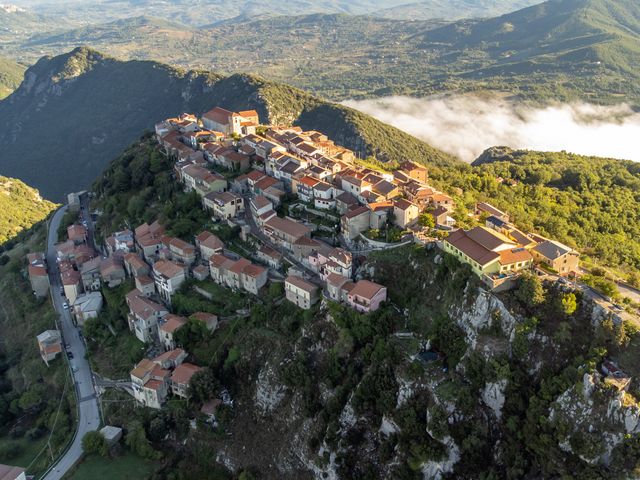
(0, 176, 56, 245)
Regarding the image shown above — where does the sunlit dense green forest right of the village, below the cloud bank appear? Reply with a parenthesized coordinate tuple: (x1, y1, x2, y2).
(433, 149, 640, 273)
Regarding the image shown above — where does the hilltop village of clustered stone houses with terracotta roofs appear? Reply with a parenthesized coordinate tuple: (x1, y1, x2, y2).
(29, 107, 579, 411)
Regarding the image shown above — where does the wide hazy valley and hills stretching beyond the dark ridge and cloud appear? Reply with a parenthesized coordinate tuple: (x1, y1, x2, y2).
(5, 0, 640, 105)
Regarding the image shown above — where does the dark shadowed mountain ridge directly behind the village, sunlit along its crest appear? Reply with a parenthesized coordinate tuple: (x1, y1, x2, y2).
(0, 48, 455, 200)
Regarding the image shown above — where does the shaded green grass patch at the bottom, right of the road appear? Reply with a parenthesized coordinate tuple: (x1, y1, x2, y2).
(64, 452, 156, 480)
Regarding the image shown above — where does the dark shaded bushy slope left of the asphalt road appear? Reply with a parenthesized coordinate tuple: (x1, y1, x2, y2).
(0, 225, 76, 474)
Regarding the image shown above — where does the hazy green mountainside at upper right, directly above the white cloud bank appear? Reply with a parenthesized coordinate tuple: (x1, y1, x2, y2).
(421, 0, 640, 103)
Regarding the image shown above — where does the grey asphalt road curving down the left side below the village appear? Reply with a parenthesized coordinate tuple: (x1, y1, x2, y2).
(43, 206, 100, 480)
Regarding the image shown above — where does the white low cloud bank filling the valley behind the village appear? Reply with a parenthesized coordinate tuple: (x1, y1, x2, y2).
(344, 95, 640, 162)
